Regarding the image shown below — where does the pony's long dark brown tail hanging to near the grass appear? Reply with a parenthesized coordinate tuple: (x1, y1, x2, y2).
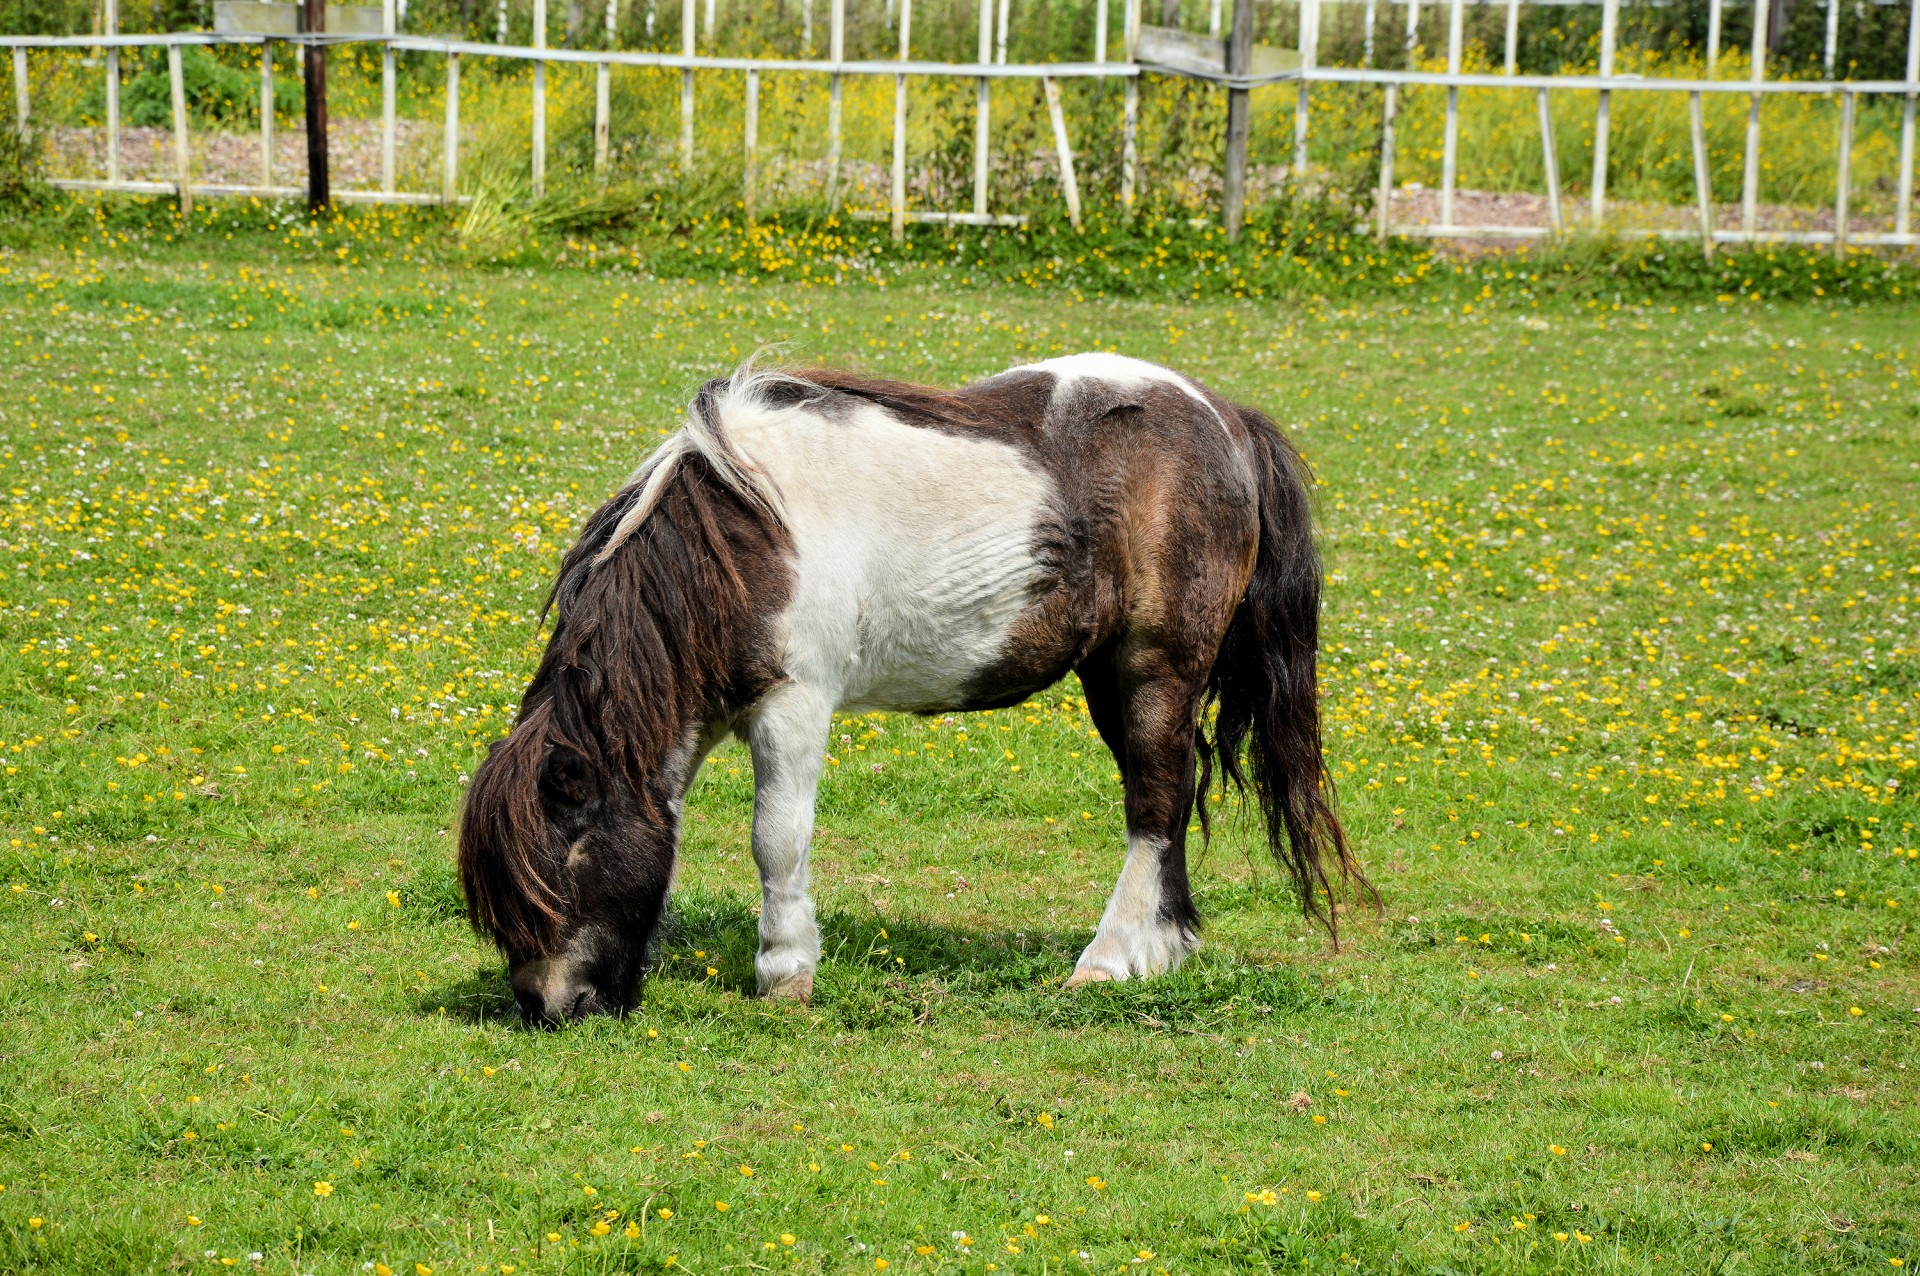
(1198, 409, 1379, 948)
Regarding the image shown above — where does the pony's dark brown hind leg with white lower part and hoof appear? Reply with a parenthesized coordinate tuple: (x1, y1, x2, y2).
(1068, 668, 1200, 988)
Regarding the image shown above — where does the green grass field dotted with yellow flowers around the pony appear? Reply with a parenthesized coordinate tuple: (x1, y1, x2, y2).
(0, 213, 1920, 1276)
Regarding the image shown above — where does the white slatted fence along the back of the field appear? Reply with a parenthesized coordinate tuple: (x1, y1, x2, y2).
(0, 0, 1920, 253)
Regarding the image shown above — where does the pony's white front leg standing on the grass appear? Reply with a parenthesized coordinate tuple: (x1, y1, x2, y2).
(747, 683, 833, 1002)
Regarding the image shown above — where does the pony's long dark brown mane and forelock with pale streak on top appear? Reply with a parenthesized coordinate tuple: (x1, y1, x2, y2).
(459, 443, 791, 956)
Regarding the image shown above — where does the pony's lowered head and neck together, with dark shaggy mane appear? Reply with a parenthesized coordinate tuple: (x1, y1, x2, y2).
(459, 378, 791, 1025)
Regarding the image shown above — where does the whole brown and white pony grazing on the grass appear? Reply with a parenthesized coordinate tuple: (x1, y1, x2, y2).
(459, 353, 1365, 1023)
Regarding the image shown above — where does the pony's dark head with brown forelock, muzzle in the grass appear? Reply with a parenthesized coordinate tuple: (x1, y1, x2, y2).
(461, 683, 674, 1025)
